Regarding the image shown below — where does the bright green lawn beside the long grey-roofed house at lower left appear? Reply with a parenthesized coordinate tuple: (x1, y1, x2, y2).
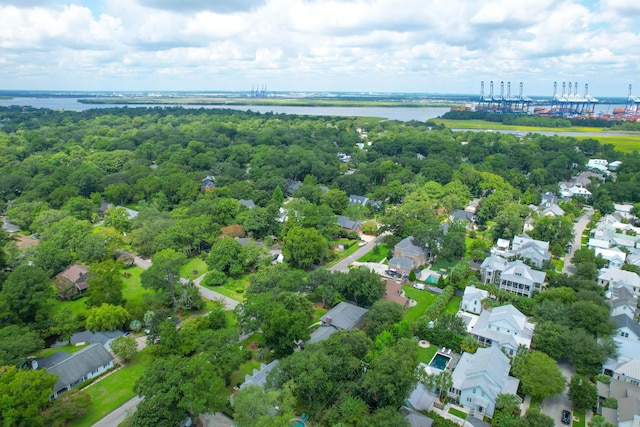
(69, 350, 152, 427)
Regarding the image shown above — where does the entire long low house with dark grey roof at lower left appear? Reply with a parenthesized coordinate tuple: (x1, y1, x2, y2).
(33, 344, 113, 399)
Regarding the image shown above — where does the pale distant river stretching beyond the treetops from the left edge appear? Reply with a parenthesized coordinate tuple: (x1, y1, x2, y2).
(0, 98, 449, 122)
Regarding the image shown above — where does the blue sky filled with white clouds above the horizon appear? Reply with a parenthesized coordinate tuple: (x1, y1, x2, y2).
(0, 0, 640, 97)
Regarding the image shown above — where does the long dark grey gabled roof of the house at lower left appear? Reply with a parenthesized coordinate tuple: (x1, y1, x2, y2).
(47, 344, 113, 391)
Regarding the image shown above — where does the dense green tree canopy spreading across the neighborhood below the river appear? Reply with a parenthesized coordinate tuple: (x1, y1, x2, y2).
(0, 107, 640, 426)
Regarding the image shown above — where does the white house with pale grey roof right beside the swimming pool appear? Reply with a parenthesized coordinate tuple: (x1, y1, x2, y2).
(449, 347, 520, 418)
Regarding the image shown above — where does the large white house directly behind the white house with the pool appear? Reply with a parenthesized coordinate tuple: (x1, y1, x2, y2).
(467, 304, 535, 356)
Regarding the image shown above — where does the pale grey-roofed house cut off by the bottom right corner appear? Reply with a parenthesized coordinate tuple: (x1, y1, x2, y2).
(596, 379, 640, 427)
